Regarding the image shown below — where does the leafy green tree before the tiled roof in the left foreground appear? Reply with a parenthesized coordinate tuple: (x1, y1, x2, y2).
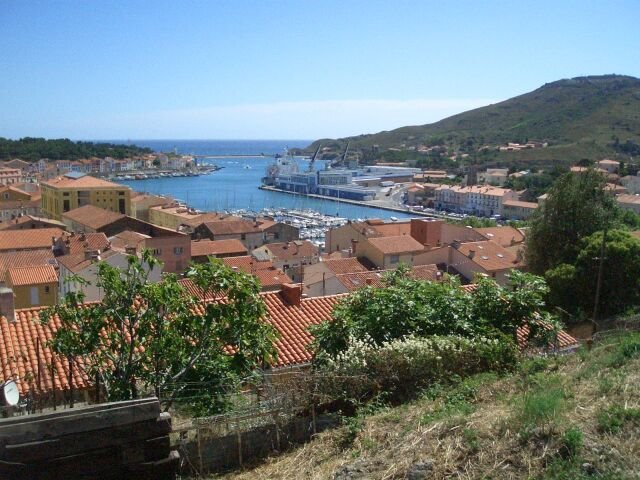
(43, 251, 275, 411)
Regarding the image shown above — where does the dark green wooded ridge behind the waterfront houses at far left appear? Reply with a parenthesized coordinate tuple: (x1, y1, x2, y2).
(0, 137, 151, 161)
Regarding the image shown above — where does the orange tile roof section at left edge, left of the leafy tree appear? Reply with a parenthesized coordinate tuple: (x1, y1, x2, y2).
(0, 308, 90, 395)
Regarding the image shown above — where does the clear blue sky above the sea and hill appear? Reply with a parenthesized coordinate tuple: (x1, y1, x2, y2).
(0, 0, 640, 139)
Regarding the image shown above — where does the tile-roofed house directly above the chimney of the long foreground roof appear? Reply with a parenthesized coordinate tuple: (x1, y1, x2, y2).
(252, 240, 320, 282)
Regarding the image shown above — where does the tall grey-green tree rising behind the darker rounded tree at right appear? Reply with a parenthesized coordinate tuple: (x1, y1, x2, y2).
(526, 169, 618, 274)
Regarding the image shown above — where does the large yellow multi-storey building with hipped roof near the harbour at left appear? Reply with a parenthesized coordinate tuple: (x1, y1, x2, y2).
(41, 172, 131, 220)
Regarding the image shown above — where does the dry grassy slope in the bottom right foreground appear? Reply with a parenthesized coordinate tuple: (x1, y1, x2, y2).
(224, 334, 640, 480)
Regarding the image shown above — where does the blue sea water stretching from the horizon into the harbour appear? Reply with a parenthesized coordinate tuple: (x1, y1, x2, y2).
(107, 140, 409, 219)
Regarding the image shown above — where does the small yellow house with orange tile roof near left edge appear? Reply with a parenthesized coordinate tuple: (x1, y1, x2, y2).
(6, 265, 58, 308)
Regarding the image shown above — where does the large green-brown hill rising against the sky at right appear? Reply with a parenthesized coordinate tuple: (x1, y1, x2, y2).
(307, 75, 640, 167)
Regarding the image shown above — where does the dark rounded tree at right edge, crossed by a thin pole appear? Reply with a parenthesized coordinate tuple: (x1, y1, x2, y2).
(546, 230, 640, 316)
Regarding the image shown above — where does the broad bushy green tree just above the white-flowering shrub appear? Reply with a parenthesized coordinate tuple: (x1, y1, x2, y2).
(312, 270, 553, 359)
